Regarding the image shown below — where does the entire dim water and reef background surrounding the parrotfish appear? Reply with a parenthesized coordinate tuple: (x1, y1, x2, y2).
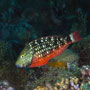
(0, 0, 90, 90)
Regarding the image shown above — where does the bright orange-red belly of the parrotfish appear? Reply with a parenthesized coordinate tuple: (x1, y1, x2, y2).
(30, 44, 68, 67)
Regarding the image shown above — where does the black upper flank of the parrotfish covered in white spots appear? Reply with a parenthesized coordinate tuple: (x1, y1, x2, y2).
(29, 36, 66, 57)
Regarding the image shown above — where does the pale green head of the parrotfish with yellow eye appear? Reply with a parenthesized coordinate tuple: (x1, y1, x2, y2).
(16, 46, 32, 68)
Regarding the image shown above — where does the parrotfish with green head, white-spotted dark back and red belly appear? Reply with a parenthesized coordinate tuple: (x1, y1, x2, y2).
(16, 31, 82, 68)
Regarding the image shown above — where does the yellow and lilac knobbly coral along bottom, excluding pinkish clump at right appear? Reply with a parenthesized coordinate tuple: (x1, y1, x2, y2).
(34, 76, 90, 90)
